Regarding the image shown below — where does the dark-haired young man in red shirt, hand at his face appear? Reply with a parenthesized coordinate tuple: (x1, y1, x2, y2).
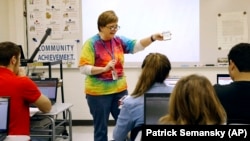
(0, 42, 51, 135)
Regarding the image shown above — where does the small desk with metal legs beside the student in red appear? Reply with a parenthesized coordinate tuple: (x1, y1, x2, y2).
(30, 103, 73, 141)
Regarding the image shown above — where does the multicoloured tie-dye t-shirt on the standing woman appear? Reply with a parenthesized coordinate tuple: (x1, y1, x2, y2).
(79, 34, 136, 95)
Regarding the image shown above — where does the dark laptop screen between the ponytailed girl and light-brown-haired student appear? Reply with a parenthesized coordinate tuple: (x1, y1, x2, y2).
(144, 93, 170, 125)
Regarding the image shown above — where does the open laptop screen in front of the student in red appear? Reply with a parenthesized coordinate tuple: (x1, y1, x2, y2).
(31, 78, 58, 107)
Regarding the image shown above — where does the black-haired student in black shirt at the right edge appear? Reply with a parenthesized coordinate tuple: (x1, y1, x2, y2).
(214, 43, 250, 124)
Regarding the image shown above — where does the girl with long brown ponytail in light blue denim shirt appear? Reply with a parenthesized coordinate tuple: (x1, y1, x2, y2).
(113, 53, 172, 141)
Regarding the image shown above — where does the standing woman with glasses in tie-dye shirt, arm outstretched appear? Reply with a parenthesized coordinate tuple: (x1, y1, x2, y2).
(79, 10, 163, 141)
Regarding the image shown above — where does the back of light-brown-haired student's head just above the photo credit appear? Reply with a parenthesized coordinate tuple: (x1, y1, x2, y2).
(159, 74, 227, 125)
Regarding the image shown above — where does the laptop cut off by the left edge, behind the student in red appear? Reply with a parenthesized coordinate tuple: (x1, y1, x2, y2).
(0, 96, 10, 141)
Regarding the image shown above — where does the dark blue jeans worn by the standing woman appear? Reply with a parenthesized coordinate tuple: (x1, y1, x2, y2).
(86, 90, 128, 141)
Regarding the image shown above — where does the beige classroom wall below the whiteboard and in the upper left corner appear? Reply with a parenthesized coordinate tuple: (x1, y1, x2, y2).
(0, 0, 227, 120)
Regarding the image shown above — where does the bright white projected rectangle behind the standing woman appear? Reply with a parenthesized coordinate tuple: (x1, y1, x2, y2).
(82, 0, 200, 66)
